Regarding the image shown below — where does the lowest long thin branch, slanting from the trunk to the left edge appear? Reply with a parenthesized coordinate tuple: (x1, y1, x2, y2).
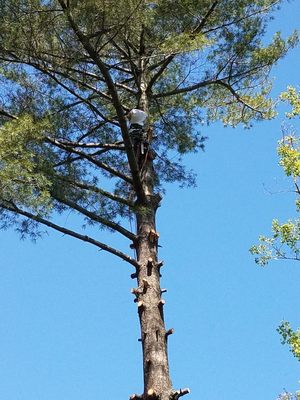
(1, 204, 139, 268)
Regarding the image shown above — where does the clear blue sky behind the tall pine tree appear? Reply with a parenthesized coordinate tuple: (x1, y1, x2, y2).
(0, 0, 300, 400)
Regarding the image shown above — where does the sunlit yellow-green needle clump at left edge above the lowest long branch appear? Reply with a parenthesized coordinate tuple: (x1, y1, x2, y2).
(0, 115, 51, 213)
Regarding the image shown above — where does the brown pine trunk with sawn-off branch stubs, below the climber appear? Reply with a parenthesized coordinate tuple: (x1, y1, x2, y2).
(134, 161, 172, 400)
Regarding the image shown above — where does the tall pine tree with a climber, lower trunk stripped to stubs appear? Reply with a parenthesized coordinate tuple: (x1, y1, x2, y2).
(0, 0, 298, 400)
